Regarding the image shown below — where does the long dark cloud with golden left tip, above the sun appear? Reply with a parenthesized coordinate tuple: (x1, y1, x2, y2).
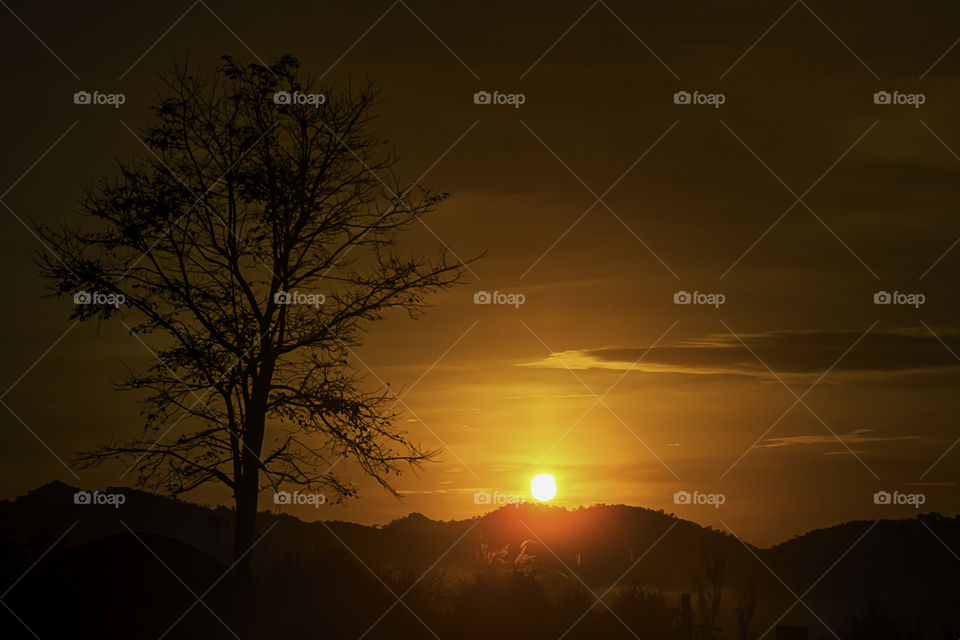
(519, 328, 960, 378)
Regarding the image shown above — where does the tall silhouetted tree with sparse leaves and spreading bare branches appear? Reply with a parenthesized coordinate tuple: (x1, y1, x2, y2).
(38, 56, 465, 573)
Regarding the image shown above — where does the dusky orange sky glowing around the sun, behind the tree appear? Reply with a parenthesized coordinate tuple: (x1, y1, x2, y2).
(0, 2, 960, 543)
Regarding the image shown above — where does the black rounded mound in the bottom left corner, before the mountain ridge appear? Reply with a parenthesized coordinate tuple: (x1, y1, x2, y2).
(2, 532, 232, 638)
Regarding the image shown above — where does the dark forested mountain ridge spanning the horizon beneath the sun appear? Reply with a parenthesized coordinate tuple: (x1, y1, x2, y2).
(0, 482, 960, 640)
